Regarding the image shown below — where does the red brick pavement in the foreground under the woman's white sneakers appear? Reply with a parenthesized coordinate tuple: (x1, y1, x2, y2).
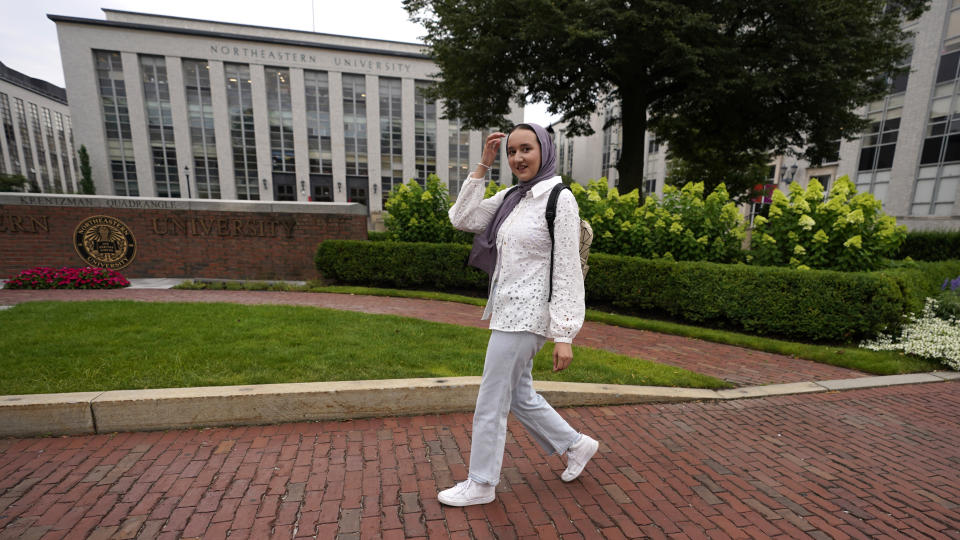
(0, 382, 960, 539)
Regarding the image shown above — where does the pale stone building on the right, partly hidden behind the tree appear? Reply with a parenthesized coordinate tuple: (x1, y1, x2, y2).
(553, 0, 960, 229)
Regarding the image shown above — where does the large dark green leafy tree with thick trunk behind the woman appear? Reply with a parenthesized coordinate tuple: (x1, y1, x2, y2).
(404, 0, 929, 195)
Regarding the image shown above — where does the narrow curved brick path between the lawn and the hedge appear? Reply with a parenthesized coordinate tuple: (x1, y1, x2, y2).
(0, 289, 864, 385)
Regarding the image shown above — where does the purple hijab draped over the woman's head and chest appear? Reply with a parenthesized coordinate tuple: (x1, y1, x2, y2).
(467, 124, 557, 276)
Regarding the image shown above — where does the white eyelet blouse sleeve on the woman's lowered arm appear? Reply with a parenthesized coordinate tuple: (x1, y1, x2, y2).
(549, 190, 585, 343)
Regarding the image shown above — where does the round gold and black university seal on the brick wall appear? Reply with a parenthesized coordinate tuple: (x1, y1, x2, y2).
(73, 216, 137, 270)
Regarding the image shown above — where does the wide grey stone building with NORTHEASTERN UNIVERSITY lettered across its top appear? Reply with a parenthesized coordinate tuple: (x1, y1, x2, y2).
(48, 9, 523, 215)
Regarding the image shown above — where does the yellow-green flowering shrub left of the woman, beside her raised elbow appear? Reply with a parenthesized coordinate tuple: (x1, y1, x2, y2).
(384, 174, 470, 243)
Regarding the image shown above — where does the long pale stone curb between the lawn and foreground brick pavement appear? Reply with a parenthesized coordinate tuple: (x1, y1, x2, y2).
(0, 371, 960, 437)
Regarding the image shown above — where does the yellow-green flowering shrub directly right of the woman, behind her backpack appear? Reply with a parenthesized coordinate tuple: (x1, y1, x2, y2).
(570, 178, 744, 262)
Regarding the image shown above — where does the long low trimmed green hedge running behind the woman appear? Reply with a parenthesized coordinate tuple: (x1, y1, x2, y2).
(316, 240, 960, 342)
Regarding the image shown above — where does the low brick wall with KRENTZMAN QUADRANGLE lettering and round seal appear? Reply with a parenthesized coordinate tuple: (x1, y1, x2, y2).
(0, 193, 367, 280)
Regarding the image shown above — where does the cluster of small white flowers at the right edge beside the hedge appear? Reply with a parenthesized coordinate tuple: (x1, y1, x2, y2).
(860, 298, 960, 371)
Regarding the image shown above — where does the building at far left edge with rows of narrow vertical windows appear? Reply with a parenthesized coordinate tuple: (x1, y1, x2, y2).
(0, 63, 80, 193)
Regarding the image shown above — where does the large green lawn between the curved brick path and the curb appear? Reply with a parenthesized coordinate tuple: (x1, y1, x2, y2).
(0, 301, 731, 395)
